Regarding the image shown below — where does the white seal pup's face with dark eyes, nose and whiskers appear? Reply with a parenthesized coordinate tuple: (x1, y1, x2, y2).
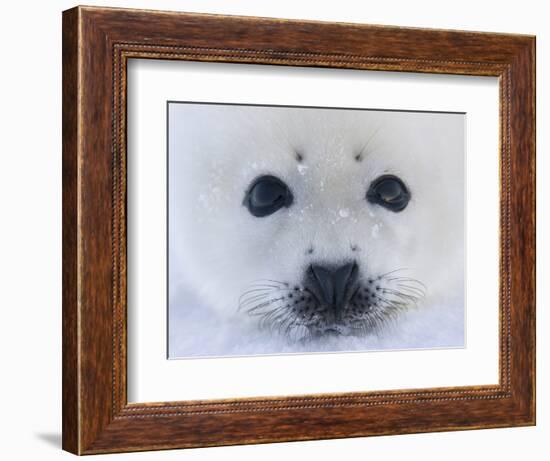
(169, 104, 464, 348)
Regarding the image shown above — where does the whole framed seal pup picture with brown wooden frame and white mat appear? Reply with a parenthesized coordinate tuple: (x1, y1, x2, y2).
(63, 7, 535, 454)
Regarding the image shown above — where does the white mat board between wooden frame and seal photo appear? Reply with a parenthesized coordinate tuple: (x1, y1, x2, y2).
(127, 60, 499, 402)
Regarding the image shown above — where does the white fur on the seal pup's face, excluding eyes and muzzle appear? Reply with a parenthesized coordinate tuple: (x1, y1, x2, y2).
(169, 104, 465, 355)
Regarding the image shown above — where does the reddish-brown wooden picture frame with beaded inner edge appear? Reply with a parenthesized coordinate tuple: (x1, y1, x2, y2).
(63, 7, 535, 454)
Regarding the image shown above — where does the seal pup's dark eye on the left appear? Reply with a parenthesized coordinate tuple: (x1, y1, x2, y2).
(244, 176, 293, 218)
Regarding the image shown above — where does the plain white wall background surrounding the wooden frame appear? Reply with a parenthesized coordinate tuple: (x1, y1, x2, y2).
(0, 0, 550, 460)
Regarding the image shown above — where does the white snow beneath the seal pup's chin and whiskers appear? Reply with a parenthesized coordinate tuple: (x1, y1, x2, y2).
(169, 280, 464, 359)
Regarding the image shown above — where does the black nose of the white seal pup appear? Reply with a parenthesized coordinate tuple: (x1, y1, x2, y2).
(309, 261, 357, 310)
